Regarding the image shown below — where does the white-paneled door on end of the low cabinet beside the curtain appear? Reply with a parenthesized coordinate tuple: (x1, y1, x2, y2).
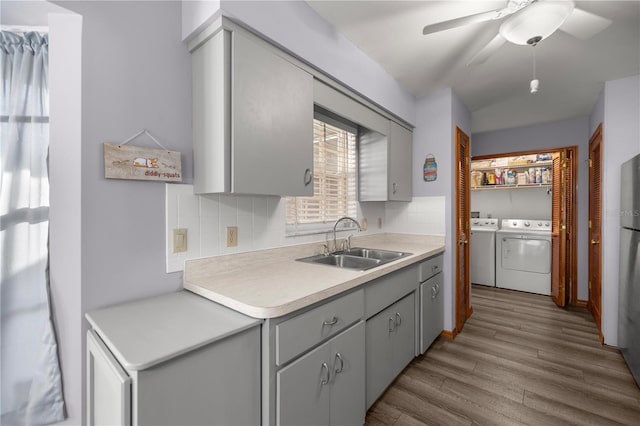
(87, 330, 131, 426)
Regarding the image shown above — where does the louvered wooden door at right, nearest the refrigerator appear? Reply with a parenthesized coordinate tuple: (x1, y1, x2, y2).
(588, 123, 602, 341)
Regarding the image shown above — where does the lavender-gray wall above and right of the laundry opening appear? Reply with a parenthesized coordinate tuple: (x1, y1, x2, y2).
(471, 117, 590, 300)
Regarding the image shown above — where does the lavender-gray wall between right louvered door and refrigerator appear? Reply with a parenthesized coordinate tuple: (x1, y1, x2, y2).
(601, 75, 640, 345)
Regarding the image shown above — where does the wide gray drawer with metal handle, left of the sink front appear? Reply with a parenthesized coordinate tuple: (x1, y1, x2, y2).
(276, 290, 364, 365)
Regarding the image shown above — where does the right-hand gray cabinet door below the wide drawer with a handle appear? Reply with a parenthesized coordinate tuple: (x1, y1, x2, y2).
(331, 322, 365, 425)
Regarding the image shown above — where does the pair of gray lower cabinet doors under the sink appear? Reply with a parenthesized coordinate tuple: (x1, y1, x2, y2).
(366, 293, 416, 409)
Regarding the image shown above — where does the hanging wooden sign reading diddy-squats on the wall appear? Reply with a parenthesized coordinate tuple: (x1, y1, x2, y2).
(103, 129, 182, 182)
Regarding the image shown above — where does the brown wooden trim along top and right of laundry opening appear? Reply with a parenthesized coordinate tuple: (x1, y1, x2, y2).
(471, 145, 585, 306)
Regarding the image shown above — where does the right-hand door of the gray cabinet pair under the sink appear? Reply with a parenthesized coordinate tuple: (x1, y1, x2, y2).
(391, 293, 416, 377)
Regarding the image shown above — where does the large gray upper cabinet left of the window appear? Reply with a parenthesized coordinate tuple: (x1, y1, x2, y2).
(190, 29, 313, 196)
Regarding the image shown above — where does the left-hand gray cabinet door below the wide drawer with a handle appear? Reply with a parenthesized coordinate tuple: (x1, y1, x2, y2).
(276, 341, 331, 426)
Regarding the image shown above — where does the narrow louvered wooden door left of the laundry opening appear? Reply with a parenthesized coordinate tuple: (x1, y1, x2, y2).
(455, 127, 471, 333)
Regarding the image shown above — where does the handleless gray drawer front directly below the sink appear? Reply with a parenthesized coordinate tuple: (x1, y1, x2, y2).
(364, 266, 418, 318)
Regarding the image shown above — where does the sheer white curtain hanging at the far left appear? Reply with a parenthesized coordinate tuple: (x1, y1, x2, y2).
(0, 31, 65, 425)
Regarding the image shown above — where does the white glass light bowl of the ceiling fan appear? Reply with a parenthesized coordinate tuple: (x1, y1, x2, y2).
(500, 1, 574, 45)
